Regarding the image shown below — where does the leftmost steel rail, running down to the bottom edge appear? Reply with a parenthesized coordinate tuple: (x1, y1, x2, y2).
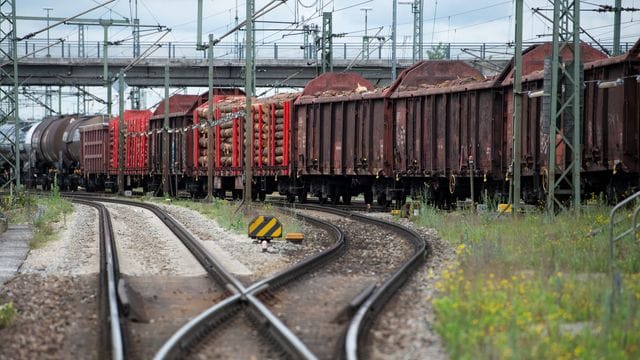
(72, 198, 125, 360)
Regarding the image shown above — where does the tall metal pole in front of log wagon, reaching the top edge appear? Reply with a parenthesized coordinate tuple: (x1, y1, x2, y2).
(242, 0, 255, 204)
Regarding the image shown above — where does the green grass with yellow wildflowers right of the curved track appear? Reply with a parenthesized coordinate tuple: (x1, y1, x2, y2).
(415, 207, 640, 359)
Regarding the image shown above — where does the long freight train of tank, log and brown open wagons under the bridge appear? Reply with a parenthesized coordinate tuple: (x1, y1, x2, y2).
(0, 41, 640, 207)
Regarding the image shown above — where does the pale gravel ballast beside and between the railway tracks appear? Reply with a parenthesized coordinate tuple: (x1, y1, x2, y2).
(0, 200, 455, 359)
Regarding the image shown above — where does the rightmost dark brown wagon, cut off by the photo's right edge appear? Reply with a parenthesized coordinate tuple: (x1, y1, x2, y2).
(581, 40, 640, 201)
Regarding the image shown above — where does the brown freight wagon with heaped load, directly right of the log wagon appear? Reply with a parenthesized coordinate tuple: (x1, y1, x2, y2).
(293, 73, 380, 203)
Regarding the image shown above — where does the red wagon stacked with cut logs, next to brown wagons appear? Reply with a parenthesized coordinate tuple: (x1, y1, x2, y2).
(194, 94, 297, 199)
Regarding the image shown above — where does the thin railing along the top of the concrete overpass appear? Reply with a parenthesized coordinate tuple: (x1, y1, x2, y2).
(8, 39, 633, 63)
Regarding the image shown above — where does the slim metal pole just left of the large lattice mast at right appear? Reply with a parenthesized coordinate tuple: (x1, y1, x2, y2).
(511, 0, 523, 215)
